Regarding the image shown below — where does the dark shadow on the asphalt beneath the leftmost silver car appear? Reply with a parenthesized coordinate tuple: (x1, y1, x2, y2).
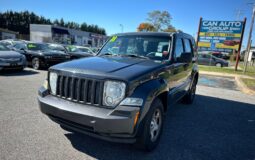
(0, 69, 39, 77)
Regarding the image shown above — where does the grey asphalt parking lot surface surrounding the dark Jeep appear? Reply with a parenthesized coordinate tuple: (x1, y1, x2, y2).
(0, 69, 255, 160)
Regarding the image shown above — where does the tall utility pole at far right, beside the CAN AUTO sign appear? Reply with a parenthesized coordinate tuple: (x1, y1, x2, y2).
(243, 3, 255, 73)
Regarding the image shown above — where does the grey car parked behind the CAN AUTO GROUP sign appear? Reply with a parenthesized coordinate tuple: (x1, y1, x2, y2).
(197, 53, 229, 67)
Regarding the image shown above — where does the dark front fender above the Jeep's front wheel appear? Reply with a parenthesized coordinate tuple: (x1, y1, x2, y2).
(130, 79, 168, 121)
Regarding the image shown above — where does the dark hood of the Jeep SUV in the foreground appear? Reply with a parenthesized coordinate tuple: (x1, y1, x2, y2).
(50, 56, 163, 81)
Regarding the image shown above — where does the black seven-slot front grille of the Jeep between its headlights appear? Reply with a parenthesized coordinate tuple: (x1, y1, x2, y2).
(57, 75, 103, 105)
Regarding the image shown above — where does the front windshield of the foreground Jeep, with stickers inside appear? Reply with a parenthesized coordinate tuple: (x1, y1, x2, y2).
(99, 35, 170, 60)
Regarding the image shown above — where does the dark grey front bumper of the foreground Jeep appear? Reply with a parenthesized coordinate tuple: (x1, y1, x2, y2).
(38, 87, 140, 143)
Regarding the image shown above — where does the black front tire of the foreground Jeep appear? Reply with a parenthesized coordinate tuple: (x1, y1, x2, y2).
(136, 98, 164, 151)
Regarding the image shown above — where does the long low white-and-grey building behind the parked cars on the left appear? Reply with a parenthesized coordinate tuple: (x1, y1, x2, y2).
(30, 24, 108, 47)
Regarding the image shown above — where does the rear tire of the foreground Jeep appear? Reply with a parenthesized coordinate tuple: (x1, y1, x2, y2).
(182, 78, 197, 104)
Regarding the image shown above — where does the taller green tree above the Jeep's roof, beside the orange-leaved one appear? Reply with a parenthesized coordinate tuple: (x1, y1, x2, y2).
(147, 10, 172, 31)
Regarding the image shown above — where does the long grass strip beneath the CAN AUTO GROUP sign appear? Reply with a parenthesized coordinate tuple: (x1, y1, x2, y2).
(199, 65, 255, 77)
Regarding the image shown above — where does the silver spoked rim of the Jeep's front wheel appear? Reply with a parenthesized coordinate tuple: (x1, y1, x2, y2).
(150, 109, 162, 142)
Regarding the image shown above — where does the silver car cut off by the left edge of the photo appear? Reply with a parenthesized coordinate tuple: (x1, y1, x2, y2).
(0, 44, 27, 70)
